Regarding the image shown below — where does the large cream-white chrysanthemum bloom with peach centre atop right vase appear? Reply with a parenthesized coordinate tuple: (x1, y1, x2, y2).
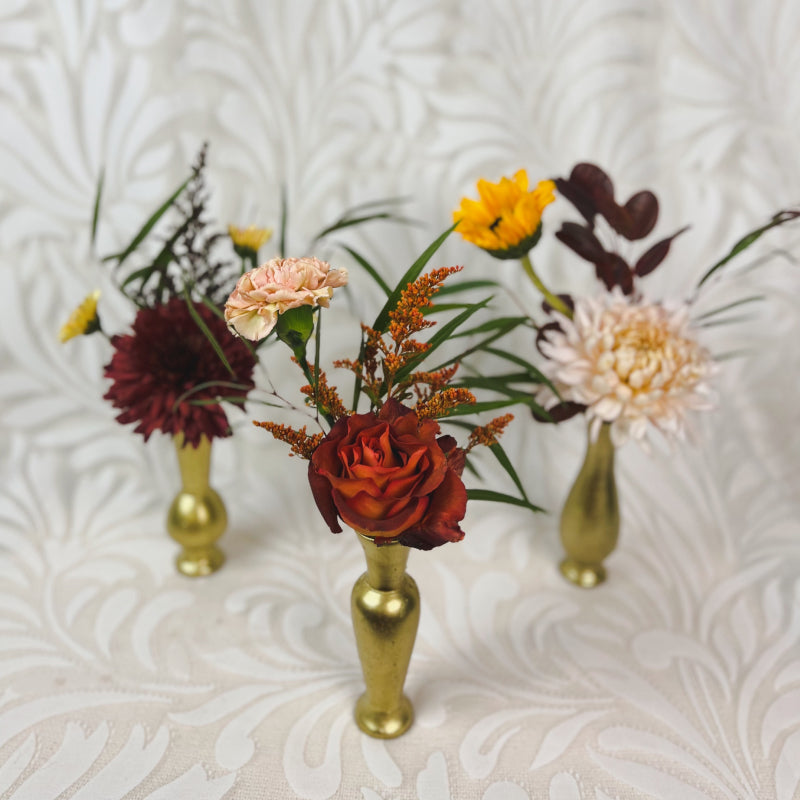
(540, 291, 715, 445)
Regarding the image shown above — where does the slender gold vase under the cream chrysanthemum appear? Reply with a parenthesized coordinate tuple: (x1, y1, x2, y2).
(560, 422, 619, 589)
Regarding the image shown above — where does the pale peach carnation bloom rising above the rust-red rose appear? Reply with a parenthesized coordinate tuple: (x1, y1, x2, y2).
(225, 258, 347, 342)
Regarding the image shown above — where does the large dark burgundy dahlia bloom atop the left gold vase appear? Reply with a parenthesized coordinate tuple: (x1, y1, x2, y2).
(105, 297, 255, 447)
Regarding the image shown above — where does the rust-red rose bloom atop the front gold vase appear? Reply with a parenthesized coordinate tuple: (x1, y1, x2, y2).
(308, 400, 467, 550)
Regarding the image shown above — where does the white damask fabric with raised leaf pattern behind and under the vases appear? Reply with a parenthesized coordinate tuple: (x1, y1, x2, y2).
(0, 0, 800, 800)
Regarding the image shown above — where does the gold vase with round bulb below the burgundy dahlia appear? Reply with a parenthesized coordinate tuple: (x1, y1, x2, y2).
(167, 434, 228, 578)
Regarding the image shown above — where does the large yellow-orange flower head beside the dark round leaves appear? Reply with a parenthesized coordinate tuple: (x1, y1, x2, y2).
(453, 169, 556, 258)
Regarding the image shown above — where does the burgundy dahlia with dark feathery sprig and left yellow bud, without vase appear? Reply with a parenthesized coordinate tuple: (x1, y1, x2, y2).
(60, 147, 256, 448)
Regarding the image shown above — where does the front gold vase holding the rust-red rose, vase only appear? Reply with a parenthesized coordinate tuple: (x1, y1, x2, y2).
(350, 534, 419, 739)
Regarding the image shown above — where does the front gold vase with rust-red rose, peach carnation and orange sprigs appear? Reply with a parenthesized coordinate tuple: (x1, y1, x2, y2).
(220, 231, 536, 738)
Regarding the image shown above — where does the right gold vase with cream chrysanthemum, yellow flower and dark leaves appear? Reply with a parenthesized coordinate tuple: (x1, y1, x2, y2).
(453, 163, 800, 587)
